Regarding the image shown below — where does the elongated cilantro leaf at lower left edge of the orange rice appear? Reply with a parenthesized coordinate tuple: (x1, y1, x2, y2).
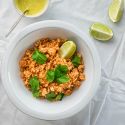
(29, 76, 40, 98)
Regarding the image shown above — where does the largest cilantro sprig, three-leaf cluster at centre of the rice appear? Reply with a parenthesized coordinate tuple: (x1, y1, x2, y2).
(46, 65, 70, 84)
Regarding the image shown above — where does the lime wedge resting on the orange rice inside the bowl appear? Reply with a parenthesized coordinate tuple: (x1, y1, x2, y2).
(59, 41, 76, 59)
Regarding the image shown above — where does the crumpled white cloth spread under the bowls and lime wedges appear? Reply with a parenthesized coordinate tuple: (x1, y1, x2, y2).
(0, 0, 125, 125)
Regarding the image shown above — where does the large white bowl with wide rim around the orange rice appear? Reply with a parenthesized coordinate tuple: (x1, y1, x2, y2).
(2, 20, 101, 120)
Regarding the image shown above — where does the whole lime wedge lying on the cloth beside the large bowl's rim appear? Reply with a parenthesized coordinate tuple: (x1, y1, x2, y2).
(90, 23, 113, 41)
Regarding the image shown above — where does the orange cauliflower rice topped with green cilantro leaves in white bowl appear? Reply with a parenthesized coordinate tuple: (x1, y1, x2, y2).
(19, 38, 85, 101)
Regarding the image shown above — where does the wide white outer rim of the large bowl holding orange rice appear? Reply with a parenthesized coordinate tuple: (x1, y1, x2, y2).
(1, 20, 101, 120)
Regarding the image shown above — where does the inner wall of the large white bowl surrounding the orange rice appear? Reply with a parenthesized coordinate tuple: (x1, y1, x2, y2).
(7, 27, 95, 119)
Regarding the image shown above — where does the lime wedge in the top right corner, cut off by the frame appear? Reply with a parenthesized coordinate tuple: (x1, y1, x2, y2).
(109, 0, 124, 22)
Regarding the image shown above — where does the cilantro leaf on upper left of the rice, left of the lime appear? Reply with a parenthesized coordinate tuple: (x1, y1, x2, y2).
(32, 50, 47, 64)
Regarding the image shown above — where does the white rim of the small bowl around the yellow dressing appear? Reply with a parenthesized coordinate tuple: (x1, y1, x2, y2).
(13, 0, 49, 18)
